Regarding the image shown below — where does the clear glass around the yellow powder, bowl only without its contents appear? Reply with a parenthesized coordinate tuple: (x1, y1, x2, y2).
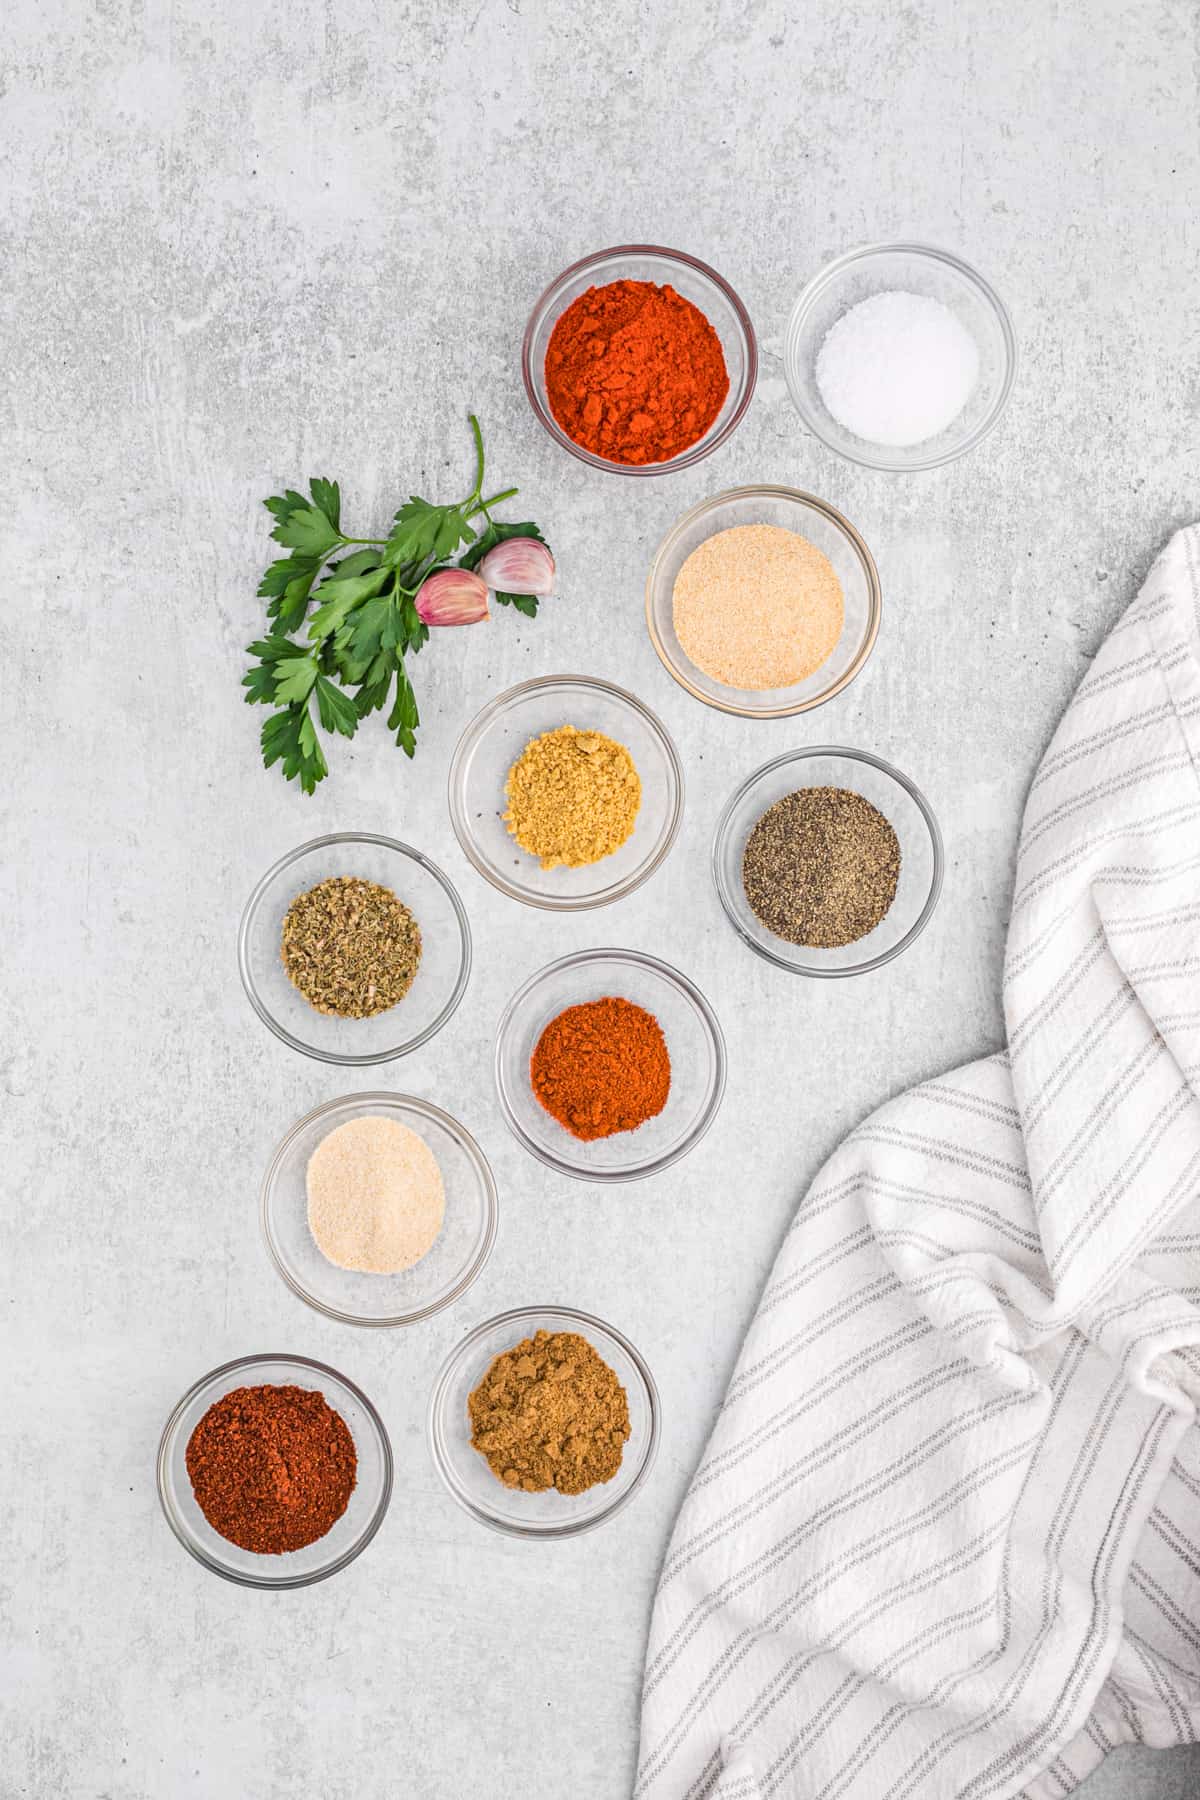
(450, 675, 684, 913)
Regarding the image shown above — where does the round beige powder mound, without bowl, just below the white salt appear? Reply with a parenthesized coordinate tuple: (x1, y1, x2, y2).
(671, 526, 846, 691)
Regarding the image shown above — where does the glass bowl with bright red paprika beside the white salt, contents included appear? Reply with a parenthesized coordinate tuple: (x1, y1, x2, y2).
(522, 243, 757, 475)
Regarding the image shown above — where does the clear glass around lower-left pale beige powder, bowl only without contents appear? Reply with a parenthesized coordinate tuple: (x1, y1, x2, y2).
(263, 1093, 497, 1325)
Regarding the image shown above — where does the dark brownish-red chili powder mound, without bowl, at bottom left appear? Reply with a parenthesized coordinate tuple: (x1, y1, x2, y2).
(187, 1388, 358, 1557)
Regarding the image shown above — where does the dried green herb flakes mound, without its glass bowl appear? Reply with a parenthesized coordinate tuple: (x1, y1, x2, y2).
(281, 875, 421, 1019)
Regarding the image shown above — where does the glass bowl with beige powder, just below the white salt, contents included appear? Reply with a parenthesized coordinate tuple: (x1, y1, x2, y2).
(646, 486, 882, 718)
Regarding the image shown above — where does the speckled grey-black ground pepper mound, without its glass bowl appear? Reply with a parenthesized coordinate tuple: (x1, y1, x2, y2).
(741, 787, 900, 950)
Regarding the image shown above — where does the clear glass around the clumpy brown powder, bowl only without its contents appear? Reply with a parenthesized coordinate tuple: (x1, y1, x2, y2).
(428, 1307, 660, 1537)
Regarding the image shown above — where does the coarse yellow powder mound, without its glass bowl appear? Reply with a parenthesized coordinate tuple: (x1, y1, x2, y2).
(504, 725, 642, 869)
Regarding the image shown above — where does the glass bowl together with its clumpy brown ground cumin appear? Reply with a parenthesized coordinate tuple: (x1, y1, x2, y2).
(428, 1307, 660, 1537)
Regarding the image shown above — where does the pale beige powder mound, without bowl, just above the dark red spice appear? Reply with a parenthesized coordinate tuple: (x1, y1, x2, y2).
(308, 1116, 446, 1274)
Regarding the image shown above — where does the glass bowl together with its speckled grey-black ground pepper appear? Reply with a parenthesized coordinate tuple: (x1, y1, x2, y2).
(712, 745, 943, 976)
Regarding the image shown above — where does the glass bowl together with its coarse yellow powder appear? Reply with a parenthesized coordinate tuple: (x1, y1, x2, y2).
(450, 675, 684, 913)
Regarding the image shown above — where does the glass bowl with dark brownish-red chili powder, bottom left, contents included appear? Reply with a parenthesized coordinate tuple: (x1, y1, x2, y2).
(158, 1354, 392, 1588)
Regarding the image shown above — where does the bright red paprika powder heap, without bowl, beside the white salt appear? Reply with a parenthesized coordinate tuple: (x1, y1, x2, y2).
(545, 281, 729, 463)
